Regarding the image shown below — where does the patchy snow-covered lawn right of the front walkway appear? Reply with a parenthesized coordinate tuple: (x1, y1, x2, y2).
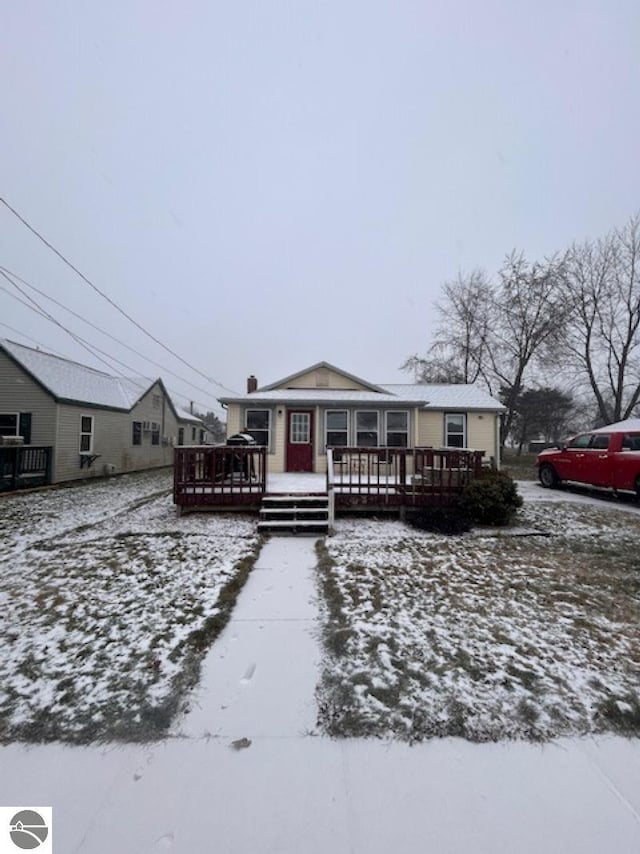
(318, 494, 640, 741)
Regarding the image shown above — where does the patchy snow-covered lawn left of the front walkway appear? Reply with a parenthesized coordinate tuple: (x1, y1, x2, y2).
(0, 470, 258, 741)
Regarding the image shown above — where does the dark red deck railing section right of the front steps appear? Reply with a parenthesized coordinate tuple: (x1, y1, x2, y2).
(327, 447, 484, 508)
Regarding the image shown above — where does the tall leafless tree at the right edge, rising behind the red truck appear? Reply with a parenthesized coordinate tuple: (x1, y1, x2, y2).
(561, 215, 640, 424)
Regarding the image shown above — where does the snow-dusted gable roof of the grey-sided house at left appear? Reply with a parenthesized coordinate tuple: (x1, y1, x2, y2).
(0, 338, 184, 420)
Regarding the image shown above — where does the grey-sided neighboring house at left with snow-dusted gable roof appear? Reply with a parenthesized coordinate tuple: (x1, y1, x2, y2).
(0, 339, 205, 483)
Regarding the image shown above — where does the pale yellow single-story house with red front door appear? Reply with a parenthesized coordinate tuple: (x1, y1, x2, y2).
(220, 362, 504, 473)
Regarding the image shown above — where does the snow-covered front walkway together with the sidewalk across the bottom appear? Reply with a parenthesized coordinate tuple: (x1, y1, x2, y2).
(0, 538, 640, 854)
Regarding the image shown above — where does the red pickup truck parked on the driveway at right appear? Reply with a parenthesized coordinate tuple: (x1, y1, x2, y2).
(535, 418, 640, 497)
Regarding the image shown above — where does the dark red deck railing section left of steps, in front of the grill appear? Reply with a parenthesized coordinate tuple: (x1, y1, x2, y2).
(173, 445, 267, 507)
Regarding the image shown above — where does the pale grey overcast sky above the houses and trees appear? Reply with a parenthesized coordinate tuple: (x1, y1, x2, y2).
(0, 0, 640, 408)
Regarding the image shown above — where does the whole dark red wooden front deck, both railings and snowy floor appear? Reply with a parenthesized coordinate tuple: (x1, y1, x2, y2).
(174, 445, 483, 518)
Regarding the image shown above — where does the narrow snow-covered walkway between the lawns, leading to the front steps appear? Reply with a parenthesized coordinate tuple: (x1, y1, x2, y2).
(178, 537, 319, 740)
